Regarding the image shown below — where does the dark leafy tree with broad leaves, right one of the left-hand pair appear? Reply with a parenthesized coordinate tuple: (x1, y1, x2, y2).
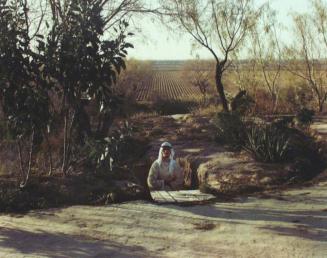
(47, 0, 133, 174)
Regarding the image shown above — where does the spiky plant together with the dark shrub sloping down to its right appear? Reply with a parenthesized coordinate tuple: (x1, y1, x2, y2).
(244, 118, 325, 179)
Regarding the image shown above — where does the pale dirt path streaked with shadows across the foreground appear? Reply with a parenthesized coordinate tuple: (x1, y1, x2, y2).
(0, 117, 327, 258)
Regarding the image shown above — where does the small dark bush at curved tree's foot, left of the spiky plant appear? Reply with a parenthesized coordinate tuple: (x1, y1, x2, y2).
(214, 112, 246, 149)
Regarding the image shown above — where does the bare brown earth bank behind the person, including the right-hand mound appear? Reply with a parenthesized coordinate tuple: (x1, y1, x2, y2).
(136, 112, 322, 195)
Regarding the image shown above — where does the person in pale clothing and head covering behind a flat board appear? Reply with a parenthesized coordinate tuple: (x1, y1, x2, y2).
(147, 142, 184, 190)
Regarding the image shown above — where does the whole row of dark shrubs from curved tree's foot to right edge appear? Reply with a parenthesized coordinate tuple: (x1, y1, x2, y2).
(214, 112, 325, 179)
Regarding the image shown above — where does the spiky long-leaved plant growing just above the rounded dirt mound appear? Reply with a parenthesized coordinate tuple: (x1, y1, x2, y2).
(243, 123, 290, 162)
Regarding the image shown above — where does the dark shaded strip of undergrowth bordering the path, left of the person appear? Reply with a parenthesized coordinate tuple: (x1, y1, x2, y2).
(0, 173, 123, 212)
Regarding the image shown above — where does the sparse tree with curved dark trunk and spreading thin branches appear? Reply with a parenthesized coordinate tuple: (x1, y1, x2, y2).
(161, 0, 261, 111)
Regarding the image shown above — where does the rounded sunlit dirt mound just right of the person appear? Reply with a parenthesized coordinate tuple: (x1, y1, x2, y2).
(197, 152, 295, 195)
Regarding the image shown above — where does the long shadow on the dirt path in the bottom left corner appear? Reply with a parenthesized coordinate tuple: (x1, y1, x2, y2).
(0, 228, 155, 258)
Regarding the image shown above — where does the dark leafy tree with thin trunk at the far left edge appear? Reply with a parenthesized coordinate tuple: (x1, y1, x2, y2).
(0, 0, 50, 187)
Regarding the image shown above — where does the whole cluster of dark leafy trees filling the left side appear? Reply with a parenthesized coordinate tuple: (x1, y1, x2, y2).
(0, 0, 133, 180)
